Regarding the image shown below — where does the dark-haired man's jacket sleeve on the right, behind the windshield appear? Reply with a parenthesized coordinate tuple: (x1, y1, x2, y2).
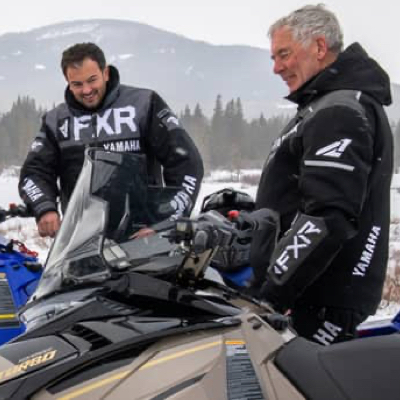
(145, 92, 204, 218)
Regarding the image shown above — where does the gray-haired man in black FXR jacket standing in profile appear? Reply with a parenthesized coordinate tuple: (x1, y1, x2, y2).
(251, 5, 393, 345)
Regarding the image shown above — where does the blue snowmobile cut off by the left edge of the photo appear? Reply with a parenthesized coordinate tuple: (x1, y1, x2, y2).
(0, 204, 42, 345)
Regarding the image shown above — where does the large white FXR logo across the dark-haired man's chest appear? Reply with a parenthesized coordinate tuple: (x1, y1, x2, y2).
(60, 106, 137, 141)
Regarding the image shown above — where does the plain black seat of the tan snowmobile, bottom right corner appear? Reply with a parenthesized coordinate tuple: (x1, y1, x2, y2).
(275, 335, 400, 400)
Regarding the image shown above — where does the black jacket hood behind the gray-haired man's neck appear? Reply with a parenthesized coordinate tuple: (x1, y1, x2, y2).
(287, 43, 392, 106)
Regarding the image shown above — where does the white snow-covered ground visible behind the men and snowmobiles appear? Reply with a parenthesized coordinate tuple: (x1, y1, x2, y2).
(0, 169, 400, 319)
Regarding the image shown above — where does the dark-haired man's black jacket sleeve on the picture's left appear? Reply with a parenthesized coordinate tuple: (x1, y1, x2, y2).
(18, 117, 59, 219)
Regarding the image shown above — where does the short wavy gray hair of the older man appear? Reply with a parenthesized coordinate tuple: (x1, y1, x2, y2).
(268, 4, 343, 53)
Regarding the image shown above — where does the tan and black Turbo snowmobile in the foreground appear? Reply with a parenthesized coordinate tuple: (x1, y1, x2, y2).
(0, 149, 400, 400)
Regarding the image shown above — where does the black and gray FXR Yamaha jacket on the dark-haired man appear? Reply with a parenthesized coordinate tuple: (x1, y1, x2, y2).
(19, 66, 203, 218)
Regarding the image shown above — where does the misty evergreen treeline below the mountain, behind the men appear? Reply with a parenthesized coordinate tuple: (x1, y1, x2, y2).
(0, 96, 288, 171)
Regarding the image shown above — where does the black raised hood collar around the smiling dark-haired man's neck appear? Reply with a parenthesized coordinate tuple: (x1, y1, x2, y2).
(64, 65, 120, 115)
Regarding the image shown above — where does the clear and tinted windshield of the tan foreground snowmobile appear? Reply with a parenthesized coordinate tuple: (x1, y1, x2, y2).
(33, 149, 180, 299)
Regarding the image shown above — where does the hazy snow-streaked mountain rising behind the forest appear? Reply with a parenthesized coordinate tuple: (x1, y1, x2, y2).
(0, 19, 400, 121)
